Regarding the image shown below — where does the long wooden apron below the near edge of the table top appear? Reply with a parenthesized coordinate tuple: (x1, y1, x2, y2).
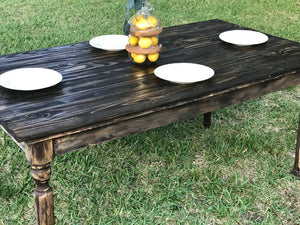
(53, 72, 300, 155)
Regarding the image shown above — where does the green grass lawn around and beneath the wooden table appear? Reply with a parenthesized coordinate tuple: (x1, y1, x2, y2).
(0, 0, 300, 225)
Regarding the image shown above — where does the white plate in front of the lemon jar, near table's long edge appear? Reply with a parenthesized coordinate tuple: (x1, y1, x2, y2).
(154, 63, 215, 84)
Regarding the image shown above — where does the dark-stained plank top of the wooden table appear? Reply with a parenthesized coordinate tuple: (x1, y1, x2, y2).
(0, 20, 300, 142)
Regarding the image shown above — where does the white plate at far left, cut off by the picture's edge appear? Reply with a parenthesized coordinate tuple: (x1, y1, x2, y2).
(0, 68, 62, 91)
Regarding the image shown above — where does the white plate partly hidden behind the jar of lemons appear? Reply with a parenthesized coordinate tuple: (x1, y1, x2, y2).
(89, 34, 128, 51)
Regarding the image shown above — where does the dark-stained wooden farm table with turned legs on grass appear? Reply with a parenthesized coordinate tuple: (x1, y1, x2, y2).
(0, 20, 300, 224)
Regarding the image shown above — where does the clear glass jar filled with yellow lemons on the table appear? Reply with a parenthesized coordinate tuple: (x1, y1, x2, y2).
(126, 1, 162, 64)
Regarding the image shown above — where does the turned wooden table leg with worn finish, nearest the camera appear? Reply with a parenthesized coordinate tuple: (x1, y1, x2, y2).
(25, 140, 54, 225)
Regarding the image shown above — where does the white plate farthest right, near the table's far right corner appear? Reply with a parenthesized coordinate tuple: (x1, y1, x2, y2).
(219, 30, 269, 46)
